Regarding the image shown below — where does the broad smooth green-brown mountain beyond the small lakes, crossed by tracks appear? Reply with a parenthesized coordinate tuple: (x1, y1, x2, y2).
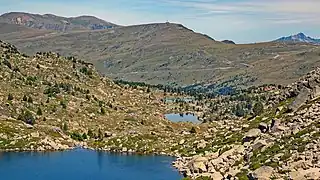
(0, 20, 320, 87)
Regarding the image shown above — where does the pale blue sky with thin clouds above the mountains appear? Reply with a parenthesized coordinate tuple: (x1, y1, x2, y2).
(0, 0, 320, 43)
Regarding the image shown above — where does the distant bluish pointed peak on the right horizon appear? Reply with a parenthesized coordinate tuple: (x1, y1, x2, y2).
(276, 33, 320, 45)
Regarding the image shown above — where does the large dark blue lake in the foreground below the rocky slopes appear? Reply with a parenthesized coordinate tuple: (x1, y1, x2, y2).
(0, 149, 182, 180)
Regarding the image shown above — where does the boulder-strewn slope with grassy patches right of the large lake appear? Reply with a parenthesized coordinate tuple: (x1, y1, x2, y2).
(174, 68, 320, 180)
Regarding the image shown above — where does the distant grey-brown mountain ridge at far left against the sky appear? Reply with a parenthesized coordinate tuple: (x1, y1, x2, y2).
(0, 12, 117, 32)
